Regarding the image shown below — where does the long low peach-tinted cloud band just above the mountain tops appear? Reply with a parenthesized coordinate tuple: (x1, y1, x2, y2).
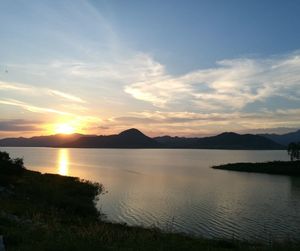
(102, 109, 300, 136)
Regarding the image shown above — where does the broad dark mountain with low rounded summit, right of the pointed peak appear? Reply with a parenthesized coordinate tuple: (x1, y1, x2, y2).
(155, 132, 284, 150)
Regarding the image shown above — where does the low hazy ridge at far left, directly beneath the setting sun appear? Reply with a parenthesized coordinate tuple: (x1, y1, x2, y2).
(0, 133, 88, 147)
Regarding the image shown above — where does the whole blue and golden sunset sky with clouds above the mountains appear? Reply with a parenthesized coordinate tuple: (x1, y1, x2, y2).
(0, 0, 300, 138)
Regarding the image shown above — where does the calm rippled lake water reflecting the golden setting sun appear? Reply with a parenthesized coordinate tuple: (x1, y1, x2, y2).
(1, 148, 300, 240)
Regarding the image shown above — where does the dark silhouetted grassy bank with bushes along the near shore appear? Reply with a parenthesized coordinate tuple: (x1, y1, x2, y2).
(0, 153, 300, 251)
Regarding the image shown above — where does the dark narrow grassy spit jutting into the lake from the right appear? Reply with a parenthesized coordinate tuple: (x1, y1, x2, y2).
(212, 161, 300, 176)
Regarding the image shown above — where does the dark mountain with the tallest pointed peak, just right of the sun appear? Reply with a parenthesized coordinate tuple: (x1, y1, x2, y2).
(62, 128, 161, 148)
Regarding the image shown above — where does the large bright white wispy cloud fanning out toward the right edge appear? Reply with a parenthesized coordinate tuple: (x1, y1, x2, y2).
(124, 51, 300, 111)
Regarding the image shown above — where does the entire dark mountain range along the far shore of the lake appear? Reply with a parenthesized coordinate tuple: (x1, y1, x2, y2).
(0, 128, 300, 150)
